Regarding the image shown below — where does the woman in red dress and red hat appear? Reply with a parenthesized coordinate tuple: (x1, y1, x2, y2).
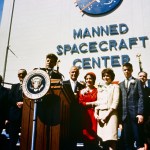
(79, 72, 98, 150)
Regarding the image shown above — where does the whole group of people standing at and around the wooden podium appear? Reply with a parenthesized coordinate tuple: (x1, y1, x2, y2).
(0, 54, 150, 150)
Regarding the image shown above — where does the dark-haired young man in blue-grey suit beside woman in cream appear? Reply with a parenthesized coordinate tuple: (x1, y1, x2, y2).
(120, 63, 144, 150)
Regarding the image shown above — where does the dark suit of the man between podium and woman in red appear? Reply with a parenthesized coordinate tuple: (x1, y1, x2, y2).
(63, 80, 84, 150)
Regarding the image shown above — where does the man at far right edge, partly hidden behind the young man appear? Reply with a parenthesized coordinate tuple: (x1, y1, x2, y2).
(138, 71, 150, 150)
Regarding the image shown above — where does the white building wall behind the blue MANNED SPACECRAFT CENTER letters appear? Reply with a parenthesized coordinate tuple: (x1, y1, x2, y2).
(0, 0, 150, 83)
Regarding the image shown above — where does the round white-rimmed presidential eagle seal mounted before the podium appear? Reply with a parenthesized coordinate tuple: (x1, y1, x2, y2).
(22, 69, 50, 100)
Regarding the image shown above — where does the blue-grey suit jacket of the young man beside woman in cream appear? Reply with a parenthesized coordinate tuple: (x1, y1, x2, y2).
(119, 78, 144, 121)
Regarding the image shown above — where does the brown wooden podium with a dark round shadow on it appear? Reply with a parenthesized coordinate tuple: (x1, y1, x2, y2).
(20, 79, 71, 150)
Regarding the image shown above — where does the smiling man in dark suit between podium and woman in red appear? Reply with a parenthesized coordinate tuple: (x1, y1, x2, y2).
(63, 66, 84, 150)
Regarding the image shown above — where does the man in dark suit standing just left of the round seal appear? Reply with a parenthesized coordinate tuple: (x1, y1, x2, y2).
(9, 69, 27, 150)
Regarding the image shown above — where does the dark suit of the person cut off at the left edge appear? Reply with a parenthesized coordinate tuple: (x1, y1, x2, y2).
(0, 85, 9, 133)
